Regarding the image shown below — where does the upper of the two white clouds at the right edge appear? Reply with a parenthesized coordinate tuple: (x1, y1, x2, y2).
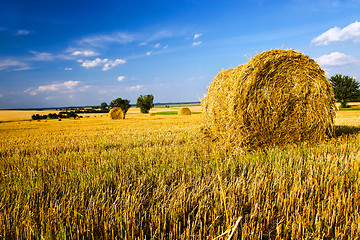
(311, 21, 360, 45)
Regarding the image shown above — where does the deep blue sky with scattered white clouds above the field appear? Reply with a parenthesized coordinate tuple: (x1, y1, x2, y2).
(0, 0, 360, 109)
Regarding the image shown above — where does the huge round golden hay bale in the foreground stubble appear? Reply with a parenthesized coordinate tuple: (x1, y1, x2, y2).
(202, 49, 335, 151)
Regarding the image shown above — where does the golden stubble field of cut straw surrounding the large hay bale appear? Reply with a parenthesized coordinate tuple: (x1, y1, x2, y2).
(0, 107, 360, 239)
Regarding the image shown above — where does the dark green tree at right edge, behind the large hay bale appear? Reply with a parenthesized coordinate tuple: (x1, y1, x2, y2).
(330, 74, 360, 108)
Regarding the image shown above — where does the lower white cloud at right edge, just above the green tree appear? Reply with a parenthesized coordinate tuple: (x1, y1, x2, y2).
(315, 52, 360, 66)
